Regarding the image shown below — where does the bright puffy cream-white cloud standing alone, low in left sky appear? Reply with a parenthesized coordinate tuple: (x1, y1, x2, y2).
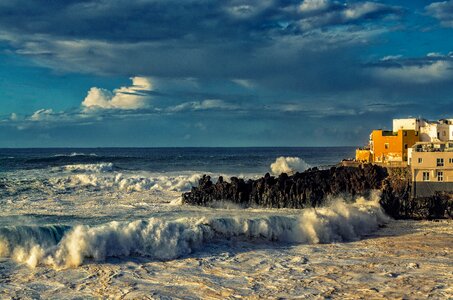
(82, 77, 153, 109)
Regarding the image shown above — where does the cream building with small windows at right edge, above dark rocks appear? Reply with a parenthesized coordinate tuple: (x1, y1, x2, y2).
(411, 141, 453, 197)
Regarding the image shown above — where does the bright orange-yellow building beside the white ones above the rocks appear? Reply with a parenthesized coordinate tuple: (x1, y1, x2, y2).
(370, 129, 419, 163)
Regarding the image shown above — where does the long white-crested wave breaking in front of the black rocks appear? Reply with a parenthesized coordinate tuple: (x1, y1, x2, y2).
(0, 199, 388, 269)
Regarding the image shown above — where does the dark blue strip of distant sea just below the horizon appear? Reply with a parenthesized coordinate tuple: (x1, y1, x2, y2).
(0, 147, 354, 174)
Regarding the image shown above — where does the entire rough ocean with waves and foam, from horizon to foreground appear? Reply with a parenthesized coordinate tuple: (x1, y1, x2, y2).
(0, 147, 453, 299)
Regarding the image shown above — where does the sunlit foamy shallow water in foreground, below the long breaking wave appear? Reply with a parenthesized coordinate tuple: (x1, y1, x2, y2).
(0, 221, 453, 299)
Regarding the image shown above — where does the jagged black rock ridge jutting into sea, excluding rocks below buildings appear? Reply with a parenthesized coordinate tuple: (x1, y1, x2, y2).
(182, 164, 388, 208)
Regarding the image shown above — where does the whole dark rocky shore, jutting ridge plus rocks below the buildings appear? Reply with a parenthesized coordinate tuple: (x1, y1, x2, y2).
(182, 164, 453, 219)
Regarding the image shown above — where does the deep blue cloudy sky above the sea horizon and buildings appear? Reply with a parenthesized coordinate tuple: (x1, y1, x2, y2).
(0, 0, 453, 147)
